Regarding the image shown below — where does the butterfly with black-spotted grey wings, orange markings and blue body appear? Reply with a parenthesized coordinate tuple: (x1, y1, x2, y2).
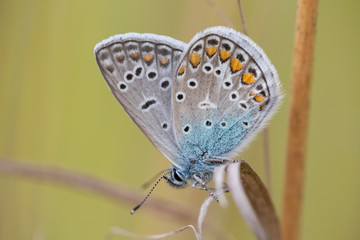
(94, 26, 282, 188)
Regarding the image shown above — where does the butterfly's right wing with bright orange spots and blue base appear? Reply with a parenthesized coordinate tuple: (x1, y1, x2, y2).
(172, 27, 281, 159)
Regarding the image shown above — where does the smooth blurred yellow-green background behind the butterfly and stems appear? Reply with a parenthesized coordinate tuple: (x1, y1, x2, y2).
(0, 0, 360, 240)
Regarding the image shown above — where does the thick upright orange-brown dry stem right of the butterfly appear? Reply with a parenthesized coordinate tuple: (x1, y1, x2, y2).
(282, 0, 318, 240)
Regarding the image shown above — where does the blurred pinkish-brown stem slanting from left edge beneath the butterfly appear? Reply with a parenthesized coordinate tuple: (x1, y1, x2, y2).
(0, 159, 197, 222)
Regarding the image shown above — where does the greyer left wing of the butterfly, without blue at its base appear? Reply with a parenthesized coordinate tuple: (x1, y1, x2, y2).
(94, 33, 185, 166)
